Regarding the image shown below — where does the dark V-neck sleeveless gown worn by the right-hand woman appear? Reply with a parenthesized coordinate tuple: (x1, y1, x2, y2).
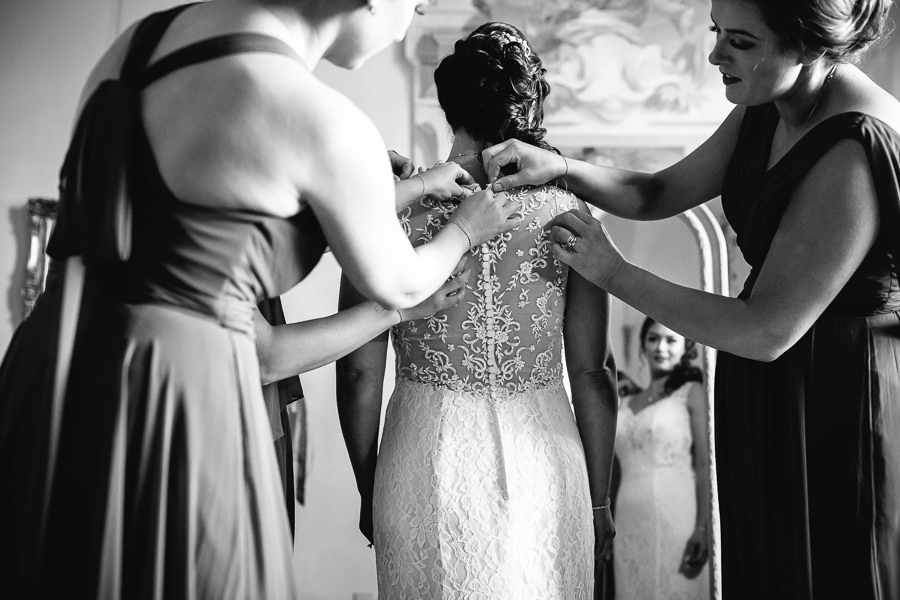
(716, 105, 900, 600)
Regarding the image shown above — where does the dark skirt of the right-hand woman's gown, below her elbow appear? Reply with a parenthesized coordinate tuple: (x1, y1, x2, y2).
(716, 312, 900, 600)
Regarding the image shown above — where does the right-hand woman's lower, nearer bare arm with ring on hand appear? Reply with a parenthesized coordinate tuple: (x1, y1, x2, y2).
(553, 140, 879, 361)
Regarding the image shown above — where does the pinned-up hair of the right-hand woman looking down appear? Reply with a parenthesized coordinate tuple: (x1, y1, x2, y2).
(755, 0, 891, 62)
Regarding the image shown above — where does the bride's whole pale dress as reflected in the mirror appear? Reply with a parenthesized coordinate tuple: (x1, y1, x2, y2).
(613, 383, 709, 600)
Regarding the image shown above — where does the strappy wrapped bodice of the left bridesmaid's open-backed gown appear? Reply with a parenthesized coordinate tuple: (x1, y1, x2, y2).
(48, 5, 326, 330)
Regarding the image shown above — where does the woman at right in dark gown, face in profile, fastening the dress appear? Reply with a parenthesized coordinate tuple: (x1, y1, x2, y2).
(474, 0, 900, 600)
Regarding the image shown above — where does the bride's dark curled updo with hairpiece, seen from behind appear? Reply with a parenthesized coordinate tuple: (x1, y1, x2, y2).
(434, 23, 556, 151)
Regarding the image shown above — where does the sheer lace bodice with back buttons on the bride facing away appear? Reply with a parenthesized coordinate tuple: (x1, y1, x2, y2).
(393, 186, 577, 401)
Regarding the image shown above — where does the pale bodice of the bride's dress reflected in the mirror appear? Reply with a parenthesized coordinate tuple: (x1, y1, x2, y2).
(616, 383, 692, 474)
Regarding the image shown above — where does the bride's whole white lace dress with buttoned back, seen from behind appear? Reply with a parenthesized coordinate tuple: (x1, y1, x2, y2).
(373, 186, 594, 600)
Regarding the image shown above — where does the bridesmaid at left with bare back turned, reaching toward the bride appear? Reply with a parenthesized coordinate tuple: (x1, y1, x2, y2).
(0, 0, 516, 599)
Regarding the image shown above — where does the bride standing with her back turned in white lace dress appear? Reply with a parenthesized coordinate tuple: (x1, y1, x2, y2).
(337, 23, 617, 600)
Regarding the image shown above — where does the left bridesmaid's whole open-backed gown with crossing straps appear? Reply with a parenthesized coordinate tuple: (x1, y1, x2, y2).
(0, 7, 325, 600)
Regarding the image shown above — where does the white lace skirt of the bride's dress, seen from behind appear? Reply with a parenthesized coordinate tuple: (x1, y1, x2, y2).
(373, 377, 594, 600)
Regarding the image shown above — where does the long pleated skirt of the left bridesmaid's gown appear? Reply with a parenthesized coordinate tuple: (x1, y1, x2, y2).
(0, 282, 296, 599)
